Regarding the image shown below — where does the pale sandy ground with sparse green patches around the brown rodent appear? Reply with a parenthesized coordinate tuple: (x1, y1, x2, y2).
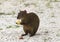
(0, 0, 60, 42)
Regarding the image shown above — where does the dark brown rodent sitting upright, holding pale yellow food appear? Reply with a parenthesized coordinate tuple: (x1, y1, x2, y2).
(16, 10, 39, 37)
